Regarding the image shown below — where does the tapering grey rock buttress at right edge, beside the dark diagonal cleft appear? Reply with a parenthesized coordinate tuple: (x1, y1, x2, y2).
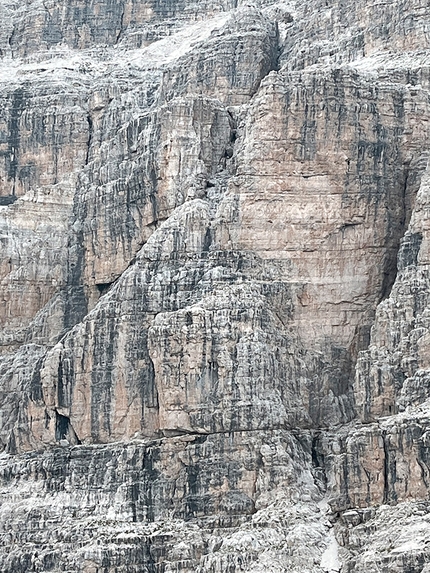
(356, 163, 430, 421)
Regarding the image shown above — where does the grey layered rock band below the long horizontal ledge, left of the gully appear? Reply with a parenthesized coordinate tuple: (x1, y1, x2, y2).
(1, 430, 327, 571)
